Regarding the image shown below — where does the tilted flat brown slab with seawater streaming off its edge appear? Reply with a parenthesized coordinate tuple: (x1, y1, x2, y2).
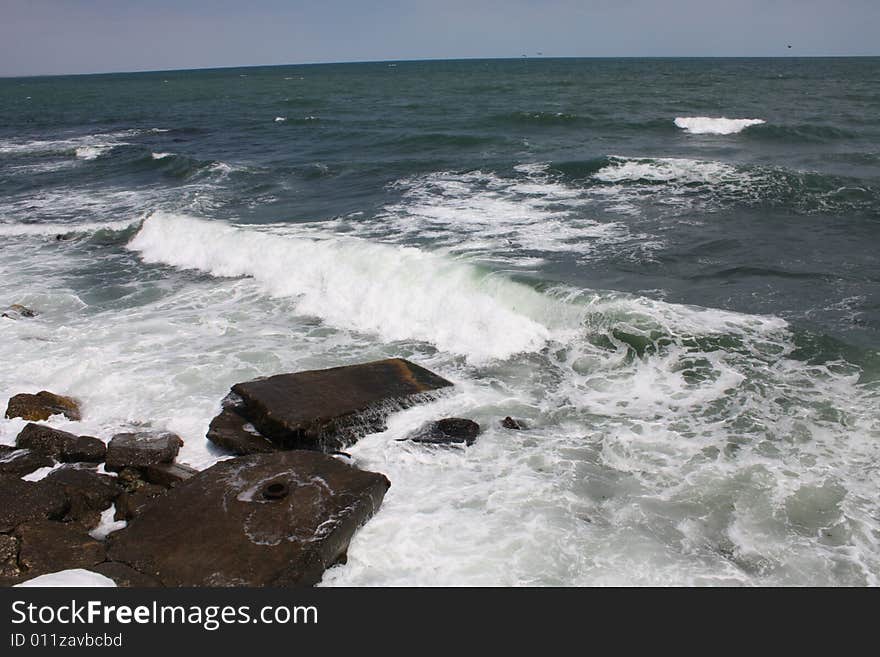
(232, 358, 452, 452)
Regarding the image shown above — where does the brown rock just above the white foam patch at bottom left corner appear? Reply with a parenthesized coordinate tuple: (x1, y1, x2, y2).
(15, 520, 106, 578)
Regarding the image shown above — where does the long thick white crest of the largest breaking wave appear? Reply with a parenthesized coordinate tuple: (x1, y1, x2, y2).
(128, 212, 561, 362)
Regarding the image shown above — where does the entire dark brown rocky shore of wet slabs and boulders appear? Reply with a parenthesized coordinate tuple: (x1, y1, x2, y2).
(0, 359, 520, 586)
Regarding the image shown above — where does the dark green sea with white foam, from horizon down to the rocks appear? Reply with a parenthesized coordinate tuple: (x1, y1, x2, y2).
(0, 58, 880, 586)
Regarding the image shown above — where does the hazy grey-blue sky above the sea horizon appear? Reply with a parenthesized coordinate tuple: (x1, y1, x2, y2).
(0, 0, 880, 76)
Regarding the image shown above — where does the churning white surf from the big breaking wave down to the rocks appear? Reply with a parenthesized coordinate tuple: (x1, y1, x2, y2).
(0, 213, 880, 585)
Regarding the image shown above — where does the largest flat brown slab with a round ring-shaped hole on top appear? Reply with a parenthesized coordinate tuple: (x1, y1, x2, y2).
(108, 451, 390, 586)
